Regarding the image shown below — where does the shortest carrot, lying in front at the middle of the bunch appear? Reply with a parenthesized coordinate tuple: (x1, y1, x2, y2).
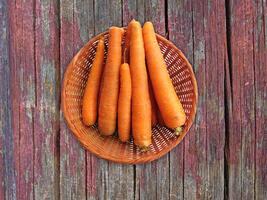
(118, 63, 132, 142)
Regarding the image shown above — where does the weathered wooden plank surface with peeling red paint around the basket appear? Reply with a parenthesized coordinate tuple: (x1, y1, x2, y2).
(0, 0, 267, 200)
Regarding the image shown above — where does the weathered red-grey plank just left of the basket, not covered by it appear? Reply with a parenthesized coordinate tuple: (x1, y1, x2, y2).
(34, 0, 60, 199)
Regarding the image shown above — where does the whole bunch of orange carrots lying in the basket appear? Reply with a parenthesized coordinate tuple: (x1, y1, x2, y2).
(82, 20, 186, 149)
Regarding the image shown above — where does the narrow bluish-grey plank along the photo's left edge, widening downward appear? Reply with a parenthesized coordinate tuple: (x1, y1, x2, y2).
(0, 1, 16, 199)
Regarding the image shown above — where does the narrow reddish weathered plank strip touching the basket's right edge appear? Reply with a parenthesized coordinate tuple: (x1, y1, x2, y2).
(189, 1, 208, 199)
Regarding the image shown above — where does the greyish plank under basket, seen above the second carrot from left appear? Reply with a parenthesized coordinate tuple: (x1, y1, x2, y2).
(93, 0, 134, 199)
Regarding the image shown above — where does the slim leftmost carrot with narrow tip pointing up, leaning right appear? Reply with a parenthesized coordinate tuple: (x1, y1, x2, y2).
(82, 38, 105, 126)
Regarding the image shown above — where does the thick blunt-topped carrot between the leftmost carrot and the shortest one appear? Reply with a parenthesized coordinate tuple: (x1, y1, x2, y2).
(98, 27, 123, 135)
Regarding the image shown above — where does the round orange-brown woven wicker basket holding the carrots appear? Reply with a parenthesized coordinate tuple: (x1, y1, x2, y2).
(62, 32, 197, 164)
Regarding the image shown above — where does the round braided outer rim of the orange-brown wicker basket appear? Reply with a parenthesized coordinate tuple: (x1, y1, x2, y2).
(61, 27, 198, 164)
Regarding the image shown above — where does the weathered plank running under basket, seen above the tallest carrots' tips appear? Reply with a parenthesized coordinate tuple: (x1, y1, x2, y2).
(123, 0, 172, 199)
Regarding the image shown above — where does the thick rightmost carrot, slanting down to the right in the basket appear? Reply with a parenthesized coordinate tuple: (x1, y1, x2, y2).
(143, 22, 186, 131)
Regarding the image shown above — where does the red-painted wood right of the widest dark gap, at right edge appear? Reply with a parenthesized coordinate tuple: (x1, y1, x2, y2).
(229, 1, 267, 199)
